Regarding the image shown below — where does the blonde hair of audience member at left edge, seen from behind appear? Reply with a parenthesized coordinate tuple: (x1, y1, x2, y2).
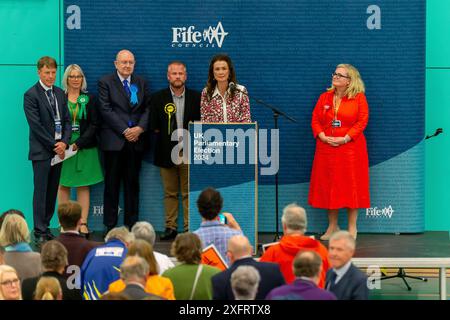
(0, 214, 30, 247)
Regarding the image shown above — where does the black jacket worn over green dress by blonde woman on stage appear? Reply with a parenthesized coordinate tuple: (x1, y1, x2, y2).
(66, 92, 99, 150)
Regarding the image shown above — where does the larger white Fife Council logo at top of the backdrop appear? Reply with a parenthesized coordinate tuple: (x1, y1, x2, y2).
(172, 21, 228, 48)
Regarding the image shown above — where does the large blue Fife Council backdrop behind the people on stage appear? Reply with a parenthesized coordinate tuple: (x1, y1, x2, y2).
(64, 0, 425, 232)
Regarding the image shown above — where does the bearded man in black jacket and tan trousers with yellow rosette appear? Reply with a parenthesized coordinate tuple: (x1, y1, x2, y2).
(150, 61, 200, 240)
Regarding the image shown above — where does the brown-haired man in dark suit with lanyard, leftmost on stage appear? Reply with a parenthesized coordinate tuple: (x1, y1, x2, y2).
(23, 56, 72, 244)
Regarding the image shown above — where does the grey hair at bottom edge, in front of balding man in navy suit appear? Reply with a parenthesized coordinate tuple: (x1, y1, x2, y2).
(230, 266, 261, 300)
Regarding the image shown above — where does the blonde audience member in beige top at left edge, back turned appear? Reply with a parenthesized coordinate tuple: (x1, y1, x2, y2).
(0, 214, 41, 281)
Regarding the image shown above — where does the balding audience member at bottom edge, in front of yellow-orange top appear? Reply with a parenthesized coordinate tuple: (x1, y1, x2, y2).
(120, 256, 162, 300)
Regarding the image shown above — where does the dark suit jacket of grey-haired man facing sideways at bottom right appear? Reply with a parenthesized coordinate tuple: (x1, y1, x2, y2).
(325, 264, 369, 300)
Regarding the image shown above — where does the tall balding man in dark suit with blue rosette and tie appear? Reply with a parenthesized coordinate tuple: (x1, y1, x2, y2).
(98, 50, 149, 232)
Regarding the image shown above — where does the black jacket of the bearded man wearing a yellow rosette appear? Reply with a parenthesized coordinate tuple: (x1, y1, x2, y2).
(149, 88, 200, 168)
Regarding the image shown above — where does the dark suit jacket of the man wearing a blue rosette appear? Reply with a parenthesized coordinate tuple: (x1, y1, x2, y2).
(98, 72, 149, 151)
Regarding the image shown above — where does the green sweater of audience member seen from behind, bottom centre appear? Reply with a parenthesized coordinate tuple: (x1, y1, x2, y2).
(162, 264, 221, 300)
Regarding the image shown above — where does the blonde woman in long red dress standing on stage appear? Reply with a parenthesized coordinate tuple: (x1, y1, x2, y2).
(308, 64, 370, 240)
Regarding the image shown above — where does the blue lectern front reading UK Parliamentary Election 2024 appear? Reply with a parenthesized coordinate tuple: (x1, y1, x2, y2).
(188, 123, 258, 250)
